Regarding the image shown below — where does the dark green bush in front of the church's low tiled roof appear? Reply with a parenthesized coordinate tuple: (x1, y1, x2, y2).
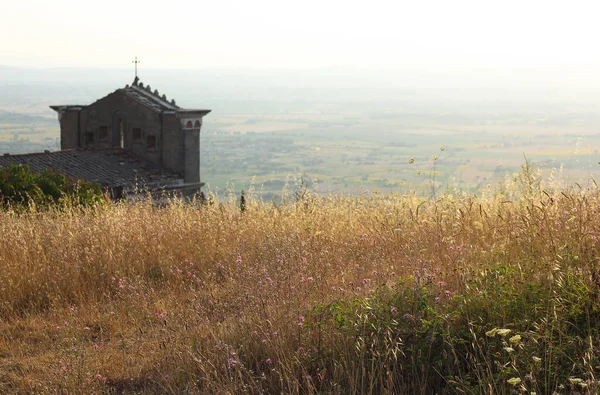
(0, 164, 104, 210)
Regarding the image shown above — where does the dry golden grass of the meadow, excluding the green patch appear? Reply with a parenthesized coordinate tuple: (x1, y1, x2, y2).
(0, 177, 600, 393)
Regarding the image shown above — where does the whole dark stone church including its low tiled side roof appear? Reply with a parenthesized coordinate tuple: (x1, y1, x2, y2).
(0, 77, 210, 196)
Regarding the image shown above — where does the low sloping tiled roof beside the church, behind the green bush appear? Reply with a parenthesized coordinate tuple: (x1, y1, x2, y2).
(0, 148, 183, 191)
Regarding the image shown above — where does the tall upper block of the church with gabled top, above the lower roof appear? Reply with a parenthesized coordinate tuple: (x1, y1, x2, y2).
(50, 77, 210, 184)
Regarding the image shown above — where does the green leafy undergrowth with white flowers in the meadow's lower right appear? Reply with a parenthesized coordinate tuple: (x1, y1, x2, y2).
(303, 267, 600, 394)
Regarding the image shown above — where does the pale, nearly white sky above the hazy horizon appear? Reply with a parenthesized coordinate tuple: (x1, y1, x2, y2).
(0, 0, 600, 72)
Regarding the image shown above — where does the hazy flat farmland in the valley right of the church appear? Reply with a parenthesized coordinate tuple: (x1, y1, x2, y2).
(201, 110, 600, 198)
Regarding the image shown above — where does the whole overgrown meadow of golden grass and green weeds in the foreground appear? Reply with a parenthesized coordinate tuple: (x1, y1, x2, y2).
(0, 166, 600, 394)
